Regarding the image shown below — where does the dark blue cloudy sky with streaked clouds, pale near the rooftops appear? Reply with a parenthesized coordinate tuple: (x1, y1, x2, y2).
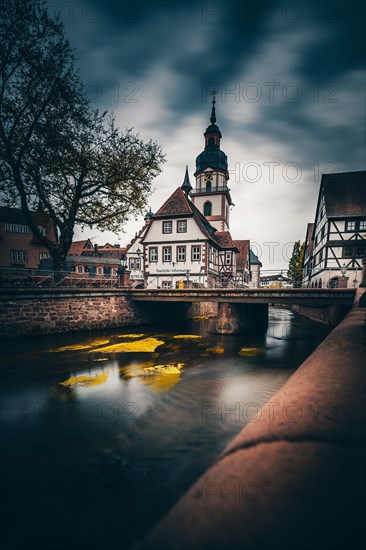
(48, 0, 365, 269)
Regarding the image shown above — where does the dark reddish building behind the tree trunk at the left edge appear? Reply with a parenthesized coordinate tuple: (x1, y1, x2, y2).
(0, 206, 56, 269)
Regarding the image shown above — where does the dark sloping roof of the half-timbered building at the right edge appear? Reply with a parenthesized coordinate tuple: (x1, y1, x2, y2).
(320, 171, 366, 217)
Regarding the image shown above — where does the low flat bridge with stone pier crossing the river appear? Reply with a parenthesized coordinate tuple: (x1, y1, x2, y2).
(128, 288, 356, 334)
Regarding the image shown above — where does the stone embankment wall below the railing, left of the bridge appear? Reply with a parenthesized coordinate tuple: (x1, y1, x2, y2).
(0, 288, 148, 338)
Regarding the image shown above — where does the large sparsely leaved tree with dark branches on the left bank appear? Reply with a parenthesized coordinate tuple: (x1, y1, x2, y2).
(0, 0, 164, 270)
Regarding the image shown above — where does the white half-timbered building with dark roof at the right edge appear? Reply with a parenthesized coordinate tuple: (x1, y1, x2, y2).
(303, 171, 366, 288)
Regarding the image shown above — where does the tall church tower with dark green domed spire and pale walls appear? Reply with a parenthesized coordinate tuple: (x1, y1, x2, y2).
(190, 91, 233, 231)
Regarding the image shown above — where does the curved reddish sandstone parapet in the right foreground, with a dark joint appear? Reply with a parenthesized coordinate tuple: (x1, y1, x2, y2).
(134, 307, 366, 550)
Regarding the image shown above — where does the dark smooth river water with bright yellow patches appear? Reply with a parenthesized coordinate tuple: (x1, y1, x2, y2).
(0, 309, 327, 550)
